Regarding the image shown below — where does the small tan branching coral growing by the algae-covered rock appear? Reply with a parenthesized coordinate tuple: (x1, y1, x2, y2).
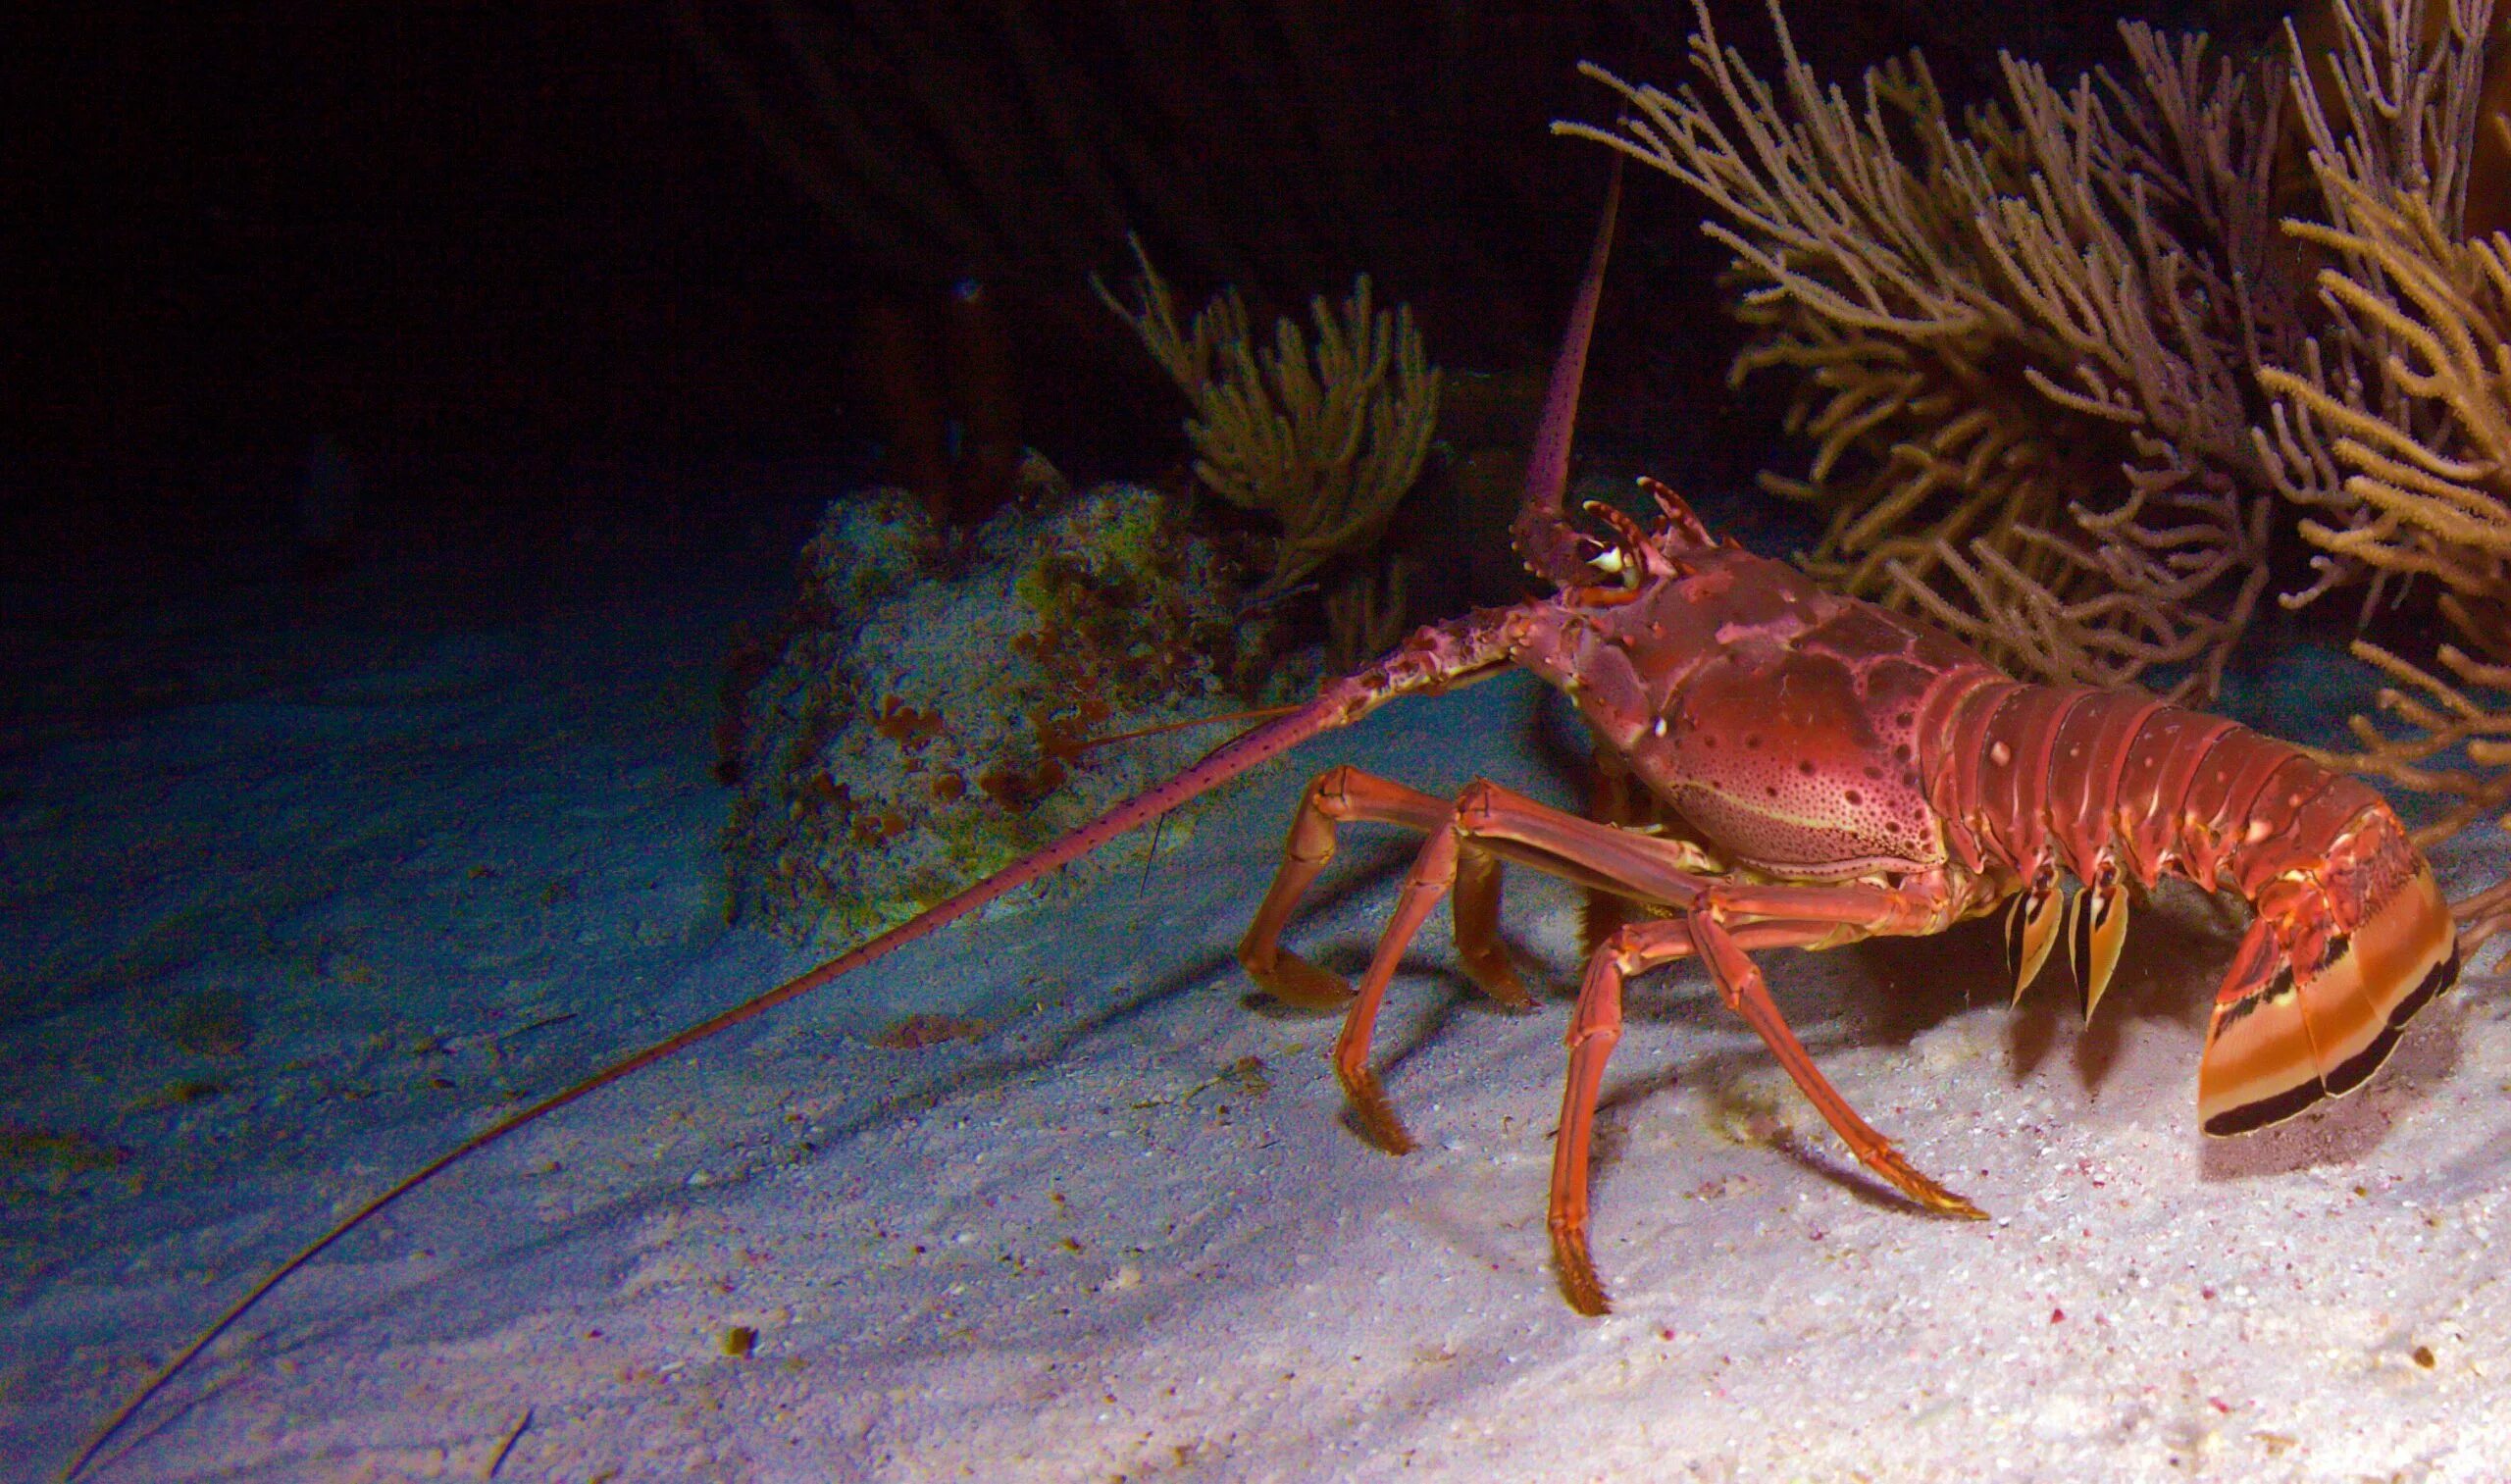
(1090, 241, 1439, 600)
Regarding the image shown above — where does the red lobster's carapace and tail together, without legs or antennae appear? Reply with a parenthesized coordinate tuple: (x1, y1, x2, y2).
(1512, 492, 2456, 1135)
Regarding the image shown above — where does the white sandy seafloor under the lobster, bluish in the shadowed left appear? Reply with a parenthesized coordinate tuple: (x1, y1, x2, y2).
(0, 502, 2511, 1481)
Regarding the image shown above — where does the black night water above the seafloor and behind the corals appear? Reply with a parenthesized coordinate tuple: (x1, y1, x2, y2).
(0, 0, 2268, 570)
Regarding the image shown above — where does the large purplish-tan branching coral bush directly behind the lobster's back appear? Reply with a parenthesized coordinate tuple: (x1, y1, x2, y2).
(1555, 0, 2297, 695)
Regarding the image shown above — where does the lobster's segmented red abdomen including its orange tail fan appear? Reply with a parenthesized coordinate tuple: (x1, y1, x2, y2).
(1921, 681, 2458, 1135)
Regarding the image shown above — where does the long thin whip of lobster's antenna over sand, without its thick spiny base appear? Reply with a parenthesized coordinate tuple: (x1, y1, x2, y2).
(60, 686, 1366, 1484)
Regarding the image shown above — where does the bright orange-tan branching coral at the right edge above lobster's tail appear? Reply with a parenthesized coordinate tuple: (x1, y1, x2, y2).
(2260, 0, 2511, 942)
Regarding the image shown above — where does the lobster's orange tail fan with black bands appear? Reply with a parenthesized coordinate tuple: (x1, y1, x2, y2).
(2197, 821, 2458, 1135)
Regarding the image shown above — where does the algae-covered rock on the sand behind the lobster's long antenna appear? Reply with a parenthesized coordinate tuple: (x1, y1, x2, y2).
(723, 485, 1313, 942)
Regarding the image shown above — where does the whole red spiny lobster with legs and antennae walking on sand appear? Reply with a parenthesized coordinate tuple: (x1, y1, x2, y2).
(66, 169, 2458, 1476)
